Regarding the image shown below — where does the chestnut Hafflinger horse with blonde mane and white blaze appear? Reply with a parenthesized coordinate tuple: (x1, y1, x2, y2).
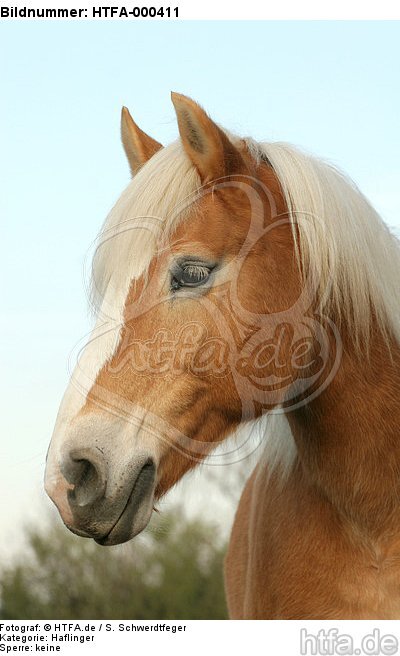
(45, 93, 400, 619)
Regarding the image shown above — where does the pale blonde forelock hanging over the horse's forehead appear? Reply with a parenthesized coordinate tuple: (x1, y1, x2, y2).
(90, 140, 200, 315)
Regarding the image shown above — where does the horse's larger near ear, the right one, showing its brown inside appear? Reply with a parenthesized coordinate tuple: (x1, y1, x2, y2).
(171, 93, 244, 182)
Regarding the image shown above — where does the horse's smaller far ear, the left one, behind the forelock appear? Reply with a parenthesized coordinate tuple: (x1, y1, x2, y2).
(121, 107, 162, 176)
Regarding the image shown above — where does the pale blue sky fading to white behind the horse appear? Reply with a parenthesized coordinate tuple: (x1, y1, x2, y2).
(0, 21, 400, 555)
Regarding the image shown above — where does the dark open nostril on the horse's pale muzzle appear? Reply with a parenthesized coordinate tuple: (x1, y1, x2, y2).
(62, 449, 107, 508)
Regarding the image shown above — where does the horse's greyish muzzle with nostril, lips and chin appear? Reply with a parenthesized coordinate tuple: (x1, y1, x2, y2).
(46, 447, 156, 545)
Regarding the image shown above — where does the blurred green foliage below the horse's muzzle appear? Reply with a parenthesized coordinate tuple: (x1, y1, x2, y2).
(0, 510, 226, 620)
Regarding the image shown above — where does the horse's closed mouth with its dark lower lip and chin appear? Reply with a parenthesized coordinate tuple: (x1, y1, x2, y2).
(94, 461, 156, 546)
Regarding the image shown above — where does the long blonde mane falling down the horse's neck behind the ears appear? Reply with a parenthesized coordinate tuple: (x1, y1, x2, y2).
(247, 139, 400, 346)
